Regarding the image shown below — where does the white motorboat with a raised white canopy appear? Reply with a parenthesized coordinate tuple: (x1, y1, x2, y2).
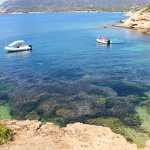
(5, 40, 32, 51)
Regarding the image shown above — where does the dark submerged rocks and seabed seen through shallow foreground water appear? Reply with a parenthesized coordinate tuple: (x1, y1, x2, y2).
(0, 69, 150, 147)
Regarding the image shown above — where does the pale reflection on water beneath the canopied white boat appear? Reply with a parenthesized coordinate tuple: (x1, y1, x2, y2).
(6, 50, 32, 57)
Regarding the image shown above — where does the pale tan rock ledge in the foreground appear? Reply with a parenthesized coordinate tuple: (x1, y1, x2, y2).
(0, 120, 150, 150)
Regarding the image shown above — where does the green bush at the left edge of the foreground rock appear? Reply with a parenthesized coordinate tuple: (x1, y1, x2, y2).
(0, 123, 12, 144)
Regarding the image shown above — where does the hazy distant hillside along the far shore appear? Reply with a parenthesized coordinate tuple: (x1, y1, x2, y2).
(0, 0, 150, 13)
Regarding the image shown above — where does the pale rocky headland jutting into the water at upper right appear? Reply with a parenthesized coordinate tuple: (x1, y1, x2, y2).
(116, 8, 150, 34)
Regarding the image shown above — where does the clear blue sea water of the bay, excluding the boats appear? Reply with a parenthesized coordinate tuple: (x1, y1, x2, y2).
(0, 13, 150, 147)
